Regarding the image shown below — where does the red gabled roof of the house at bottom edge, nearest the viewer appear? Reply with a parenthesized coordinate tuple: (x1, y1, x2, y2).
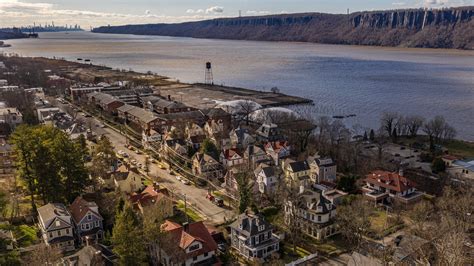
(161, 220, 217, 258)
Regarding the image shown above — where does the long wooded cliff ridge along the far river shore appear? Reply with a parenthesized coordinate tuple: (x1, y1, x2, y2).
(94, 7, 474, 49)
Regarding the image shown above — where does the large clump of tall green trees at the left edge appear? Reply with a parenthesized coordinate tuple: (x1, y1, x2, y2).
(11, 125, 89, 210)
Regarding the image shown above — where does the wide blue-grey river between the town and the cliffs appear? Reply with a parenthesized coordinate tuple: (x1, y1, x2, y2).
(0, 32, 474, 141)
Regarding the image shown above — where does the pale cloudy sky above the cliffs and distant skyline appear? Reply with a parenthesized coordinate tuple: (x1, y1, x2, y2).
(0, 0, 474, 29)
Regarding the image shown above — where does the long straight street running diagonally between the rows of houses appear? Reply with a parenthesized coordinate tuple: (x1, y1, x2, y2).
(71, 107, 236, 224)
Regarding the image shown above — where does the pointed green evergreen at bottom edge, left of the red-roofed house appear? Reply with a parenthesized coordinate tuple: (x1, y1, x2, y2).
(112, 205, 147, 265)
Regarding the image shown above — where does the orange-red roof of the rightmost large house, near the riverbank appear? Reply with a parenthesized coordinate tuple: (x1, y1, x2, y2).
(365, 171, 416, 192)
